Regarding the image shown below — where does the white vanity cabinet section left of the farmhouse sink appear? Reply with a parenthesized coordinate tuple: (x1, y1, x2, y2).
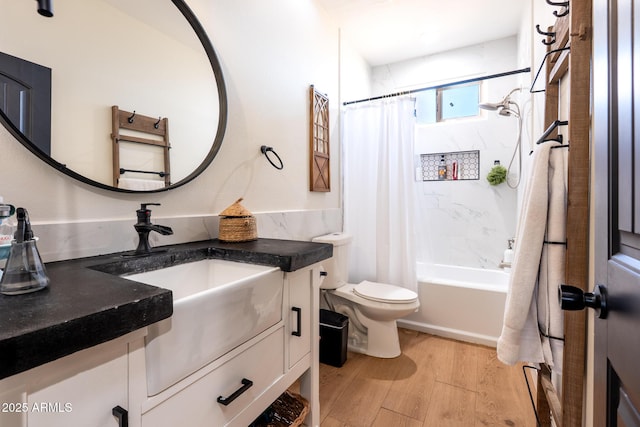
(0, 331, 144, 427)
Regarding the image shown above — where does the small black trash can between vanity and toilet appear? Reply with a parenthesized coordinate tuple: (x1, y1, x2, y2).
(320, 309, 349, 368)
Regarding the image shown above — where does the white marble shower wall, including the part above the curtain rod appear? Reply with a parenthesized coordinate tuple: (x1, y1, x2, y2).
(373, 36, 530, 269)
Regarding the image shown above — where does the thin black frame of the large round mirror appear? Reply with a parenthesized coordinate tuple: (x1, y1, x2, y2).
(0, 0, 228, 193)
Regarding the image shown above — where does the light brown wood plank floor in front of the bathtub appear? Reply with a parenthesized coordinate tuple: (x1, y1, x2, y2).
(320, 329, 535, 427)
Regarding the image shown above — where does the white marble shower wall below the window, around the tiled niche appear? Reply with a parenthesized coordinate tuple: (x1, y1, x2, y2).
(415, 115, 528, 269)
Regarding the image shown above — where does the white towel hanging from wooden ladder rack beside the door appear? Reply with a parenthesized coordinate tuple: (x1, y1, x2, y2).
(497, 142, 566, 372)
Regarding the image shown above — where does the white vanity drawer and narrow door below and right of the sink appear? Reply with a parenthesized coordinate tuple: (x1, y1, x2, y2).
(138, 264, 320, 427)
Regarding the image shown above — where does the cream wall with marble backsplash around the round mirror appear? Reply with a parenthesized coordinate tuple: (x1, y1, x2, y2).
(0, 0, 367, 261)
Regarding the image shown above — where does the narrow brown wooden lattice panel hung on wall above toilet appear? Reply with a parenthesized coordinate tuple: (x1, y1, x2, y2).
(309, 85, 331, 191)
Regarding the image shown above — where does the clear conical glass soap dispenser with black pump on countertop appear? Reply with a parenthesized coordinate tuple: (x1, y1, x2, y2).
(0, 208, 49, 295)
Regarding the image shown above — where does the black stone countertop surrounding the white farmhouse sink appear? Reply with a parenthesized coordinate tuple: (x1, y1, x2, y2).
(0, 239, 333, 379)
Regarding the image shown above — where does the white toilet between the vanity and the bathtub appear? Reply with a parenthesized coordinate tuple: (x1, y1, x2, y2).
(313, 233, 420, 358)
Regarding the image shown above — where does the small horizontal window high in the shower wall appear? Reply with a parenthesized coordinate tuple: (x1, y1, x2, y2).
(415, 82, 480, 124)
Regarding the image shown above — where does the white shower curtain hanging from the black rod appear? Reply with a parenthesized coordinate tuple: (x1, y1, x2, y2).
(342, 97, 417, 291)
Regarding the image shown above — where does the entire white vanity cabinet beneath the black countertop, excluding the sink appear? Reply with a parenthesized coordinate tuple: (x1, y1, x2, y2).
(0, 264, 320, 427)
